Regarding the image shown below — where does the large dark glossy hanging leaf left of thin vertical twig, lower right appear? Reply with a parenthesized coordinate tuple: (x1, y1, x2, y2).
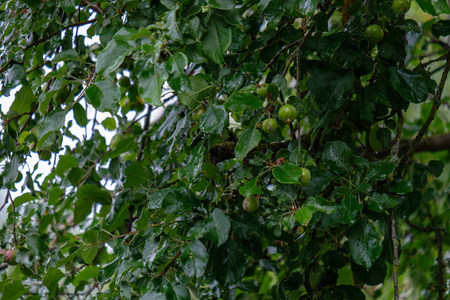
(347, 218, 383, 269)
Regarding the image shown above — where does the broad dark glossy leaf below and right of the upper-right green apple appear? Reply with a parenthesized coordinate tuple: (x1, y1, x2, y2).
(389, 67, 429, 103)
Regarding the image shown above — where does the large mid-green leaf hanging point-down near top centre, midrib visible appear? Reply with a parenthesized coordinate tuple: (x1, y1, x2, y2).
(203, 16, 231, 64)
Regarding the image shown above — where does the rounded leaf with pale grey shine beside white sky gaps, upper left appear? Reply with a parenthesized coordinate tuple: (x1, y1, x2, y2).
(86, 78, 120, 115)
